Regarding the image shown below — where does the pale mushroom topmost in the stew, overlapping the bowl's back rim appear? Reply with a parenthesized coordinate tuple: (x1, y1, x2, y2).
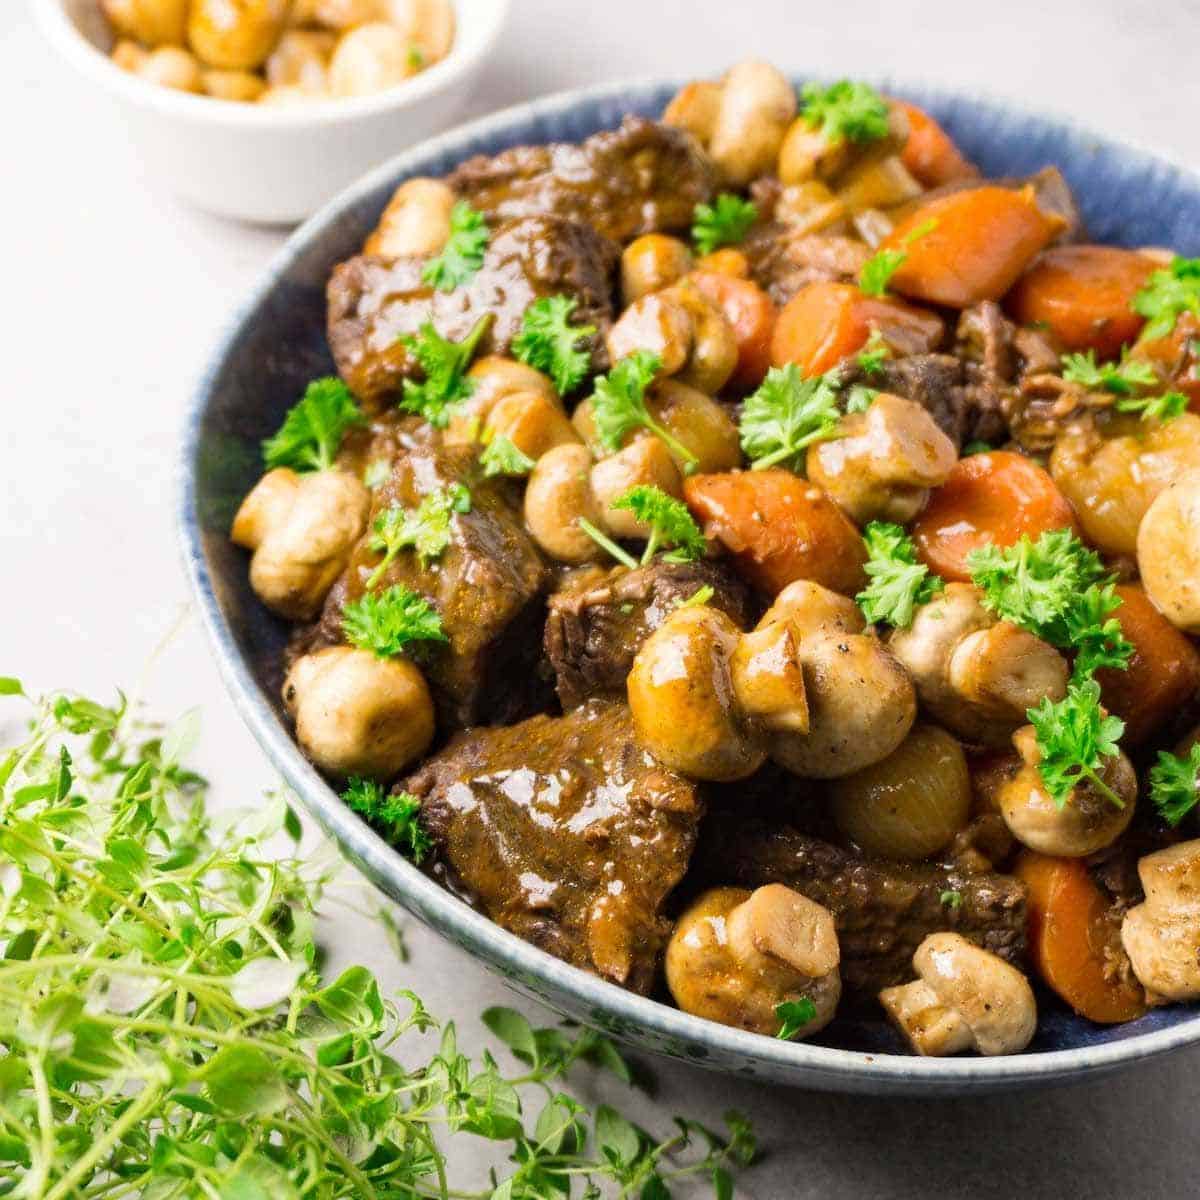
(662, 61, 796, 185)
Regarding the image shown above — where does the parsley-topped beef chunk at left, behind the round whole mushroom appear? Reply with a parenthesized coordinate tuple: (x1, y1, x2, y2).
(307, 444, 552, 730)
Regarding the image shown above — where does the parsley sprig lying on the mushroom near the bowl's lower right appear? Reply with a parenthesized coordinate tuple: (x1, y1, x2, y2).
(1026, 679, 1124, 809)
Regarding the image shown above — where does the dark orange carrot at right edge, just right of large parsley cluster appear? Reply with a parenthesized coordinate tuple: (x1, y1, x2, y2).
(1096, 583, 1200, 745)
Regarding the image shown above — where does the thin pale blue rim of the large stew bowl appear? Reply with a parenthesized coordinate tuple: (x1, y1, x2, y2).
(176, 72, 1200, 1094)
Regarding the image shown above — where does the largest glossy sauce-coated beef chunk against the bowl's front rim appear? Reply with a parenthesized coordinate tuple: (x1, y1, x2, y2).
(400, 702, 701, 992)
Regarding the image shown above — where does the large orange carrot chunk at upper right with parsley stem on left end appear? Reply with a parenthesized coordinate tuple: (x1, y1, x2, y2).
(880, 184, 1063, 308)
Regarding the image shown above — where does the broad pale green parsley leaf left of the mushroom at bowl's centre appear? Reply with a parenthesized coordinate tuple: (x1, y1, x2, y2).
(738, 362, 841, 470)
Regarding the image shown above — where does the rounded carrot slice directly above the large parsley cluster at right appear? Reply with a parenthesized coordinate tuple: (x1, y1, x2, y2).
(912, 450, 1075, 580)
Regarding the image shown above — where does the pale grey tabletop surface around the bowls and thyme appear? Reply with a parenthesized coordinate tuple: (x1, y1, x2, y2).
(7, 0, 1200, 1200)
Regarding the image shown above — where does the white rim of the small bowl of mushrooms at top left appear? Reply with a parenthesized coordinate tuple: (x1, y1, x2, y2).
(32, 0, 512, 130)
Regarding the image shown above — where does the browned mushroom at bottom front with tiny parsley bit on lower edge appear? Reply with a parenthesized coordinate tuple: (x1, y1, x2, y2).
(666, 883, 841, 1037)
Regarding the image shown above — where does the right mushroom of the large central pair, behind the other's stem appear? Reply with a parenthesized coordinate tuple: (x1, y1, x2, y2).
(758, 580, 917, 779)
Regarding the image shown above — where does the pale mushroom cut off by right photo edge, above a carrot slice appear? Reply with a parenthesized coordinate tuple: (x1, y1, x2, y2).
(1138, 470, 1200, 634)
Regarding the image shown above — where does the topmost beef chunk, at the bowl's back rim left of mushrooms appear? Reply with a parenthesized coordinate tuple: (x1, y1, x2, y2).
(446, 116, 716, 242)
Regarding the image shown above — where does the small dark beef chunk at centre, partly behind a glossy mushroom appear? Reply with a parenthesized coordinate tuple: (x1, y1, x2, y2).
(546, 559, 750, 708)
